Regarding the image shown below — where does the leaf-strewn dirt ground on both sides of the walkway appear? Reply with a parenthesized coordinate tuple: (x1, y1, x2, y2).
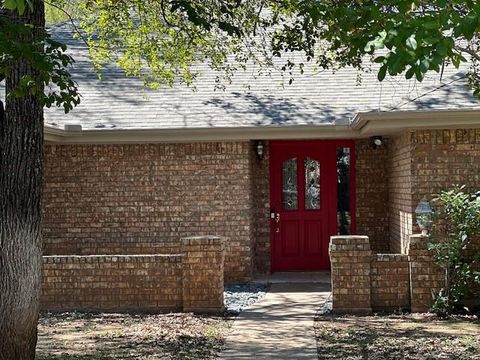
(37, 312, 480, 360)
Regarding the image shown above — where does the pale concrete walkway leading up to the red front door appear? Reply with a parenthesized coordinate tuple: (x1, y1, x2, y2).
(221, 274, 330, 360)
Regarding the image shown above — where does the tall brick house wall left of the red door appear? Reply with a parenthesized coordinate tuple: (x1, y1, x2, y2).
(43, 142, 253, 281)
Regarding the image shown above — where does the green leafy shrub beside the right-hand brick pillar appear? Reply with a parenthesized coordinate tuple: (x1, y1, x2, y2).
(429, 186, 480, 313)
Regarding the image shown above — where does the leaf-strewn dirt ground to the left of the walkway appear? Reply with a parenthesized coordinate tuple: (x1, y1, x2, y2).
(36, 312, 230, 360)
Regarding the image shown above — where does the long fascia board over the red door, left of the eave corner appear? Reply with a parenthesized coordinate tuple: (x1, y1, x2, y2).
(45, 124, 360, 144)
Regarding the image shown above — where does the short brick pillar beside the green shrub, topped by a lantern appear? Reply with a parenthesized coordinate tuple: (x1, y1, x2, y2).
(407, 234, 445, 312)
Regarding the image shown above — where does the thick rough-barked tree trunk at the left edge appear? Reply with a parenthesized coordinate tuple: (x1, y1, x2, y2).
(0, 0, 44, 360)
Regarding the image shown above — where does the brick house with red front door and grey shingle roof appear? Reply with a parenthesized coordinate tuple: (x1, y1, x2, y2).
(39, 26, 480, 281)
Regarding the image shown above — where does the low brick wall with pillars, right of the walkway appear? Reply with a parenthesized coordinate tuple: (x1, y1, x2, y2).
(330, 235, 443, 313)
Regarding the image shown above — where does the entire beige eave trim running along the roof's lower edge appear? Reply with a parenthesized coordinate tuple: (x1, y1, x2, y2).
(45, 109, 480, 144)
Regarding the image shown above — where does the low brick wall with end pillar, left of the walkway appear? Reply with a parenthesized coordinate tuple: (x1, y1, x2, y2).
(40, 236, 225, 313)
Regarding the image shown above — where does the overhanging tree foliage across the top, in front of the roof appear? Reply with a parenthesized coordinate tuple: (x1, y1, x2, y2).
(3, 0, 480, 104)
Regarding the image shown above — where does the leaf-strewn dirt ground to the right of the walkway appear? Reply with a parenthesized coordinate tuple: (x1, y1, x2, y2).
(315, 314, 480, 360)
